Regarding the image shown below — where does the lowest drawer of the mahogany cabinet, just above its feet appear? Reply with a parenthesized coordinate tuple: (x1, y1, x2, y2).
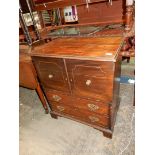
(51, 102, 110, 128)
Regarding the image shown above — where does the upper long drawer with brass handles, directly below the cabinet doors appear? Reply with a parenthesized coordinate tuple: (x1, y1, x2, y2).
(45, 90, 110, 116)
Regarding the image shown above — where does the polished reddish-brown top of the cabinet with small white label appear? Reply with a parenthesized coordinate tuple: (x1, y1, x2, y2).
(31, 36, 123, 61)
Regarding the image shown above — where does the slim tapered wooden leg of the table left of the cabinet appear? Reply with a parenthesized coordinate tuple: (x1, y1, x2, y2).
(36, 84, 49, 114)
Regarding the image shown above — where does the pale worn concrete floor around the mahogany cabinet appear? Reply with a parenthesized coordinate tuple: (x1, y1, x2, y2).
(19, 58, 135, 155)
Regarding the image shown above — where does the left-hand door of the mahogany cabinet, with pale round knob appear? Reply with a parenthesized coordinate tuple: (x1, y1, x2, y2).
(32, 57, 69, 92)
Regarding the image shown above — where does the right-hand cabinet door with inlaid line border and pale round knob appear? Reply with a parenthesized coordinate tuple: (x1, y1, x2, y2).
(66, 60, 114, 102)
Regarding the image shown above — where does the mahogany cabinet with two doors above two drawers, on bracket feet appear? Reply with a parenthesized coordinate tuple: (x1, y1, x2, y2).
(31, 36, 123, 138)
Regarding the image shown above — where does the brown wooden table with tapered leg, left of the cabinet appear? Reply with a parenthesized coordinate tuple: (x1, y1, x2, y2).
(19, 45, 48, 113)
